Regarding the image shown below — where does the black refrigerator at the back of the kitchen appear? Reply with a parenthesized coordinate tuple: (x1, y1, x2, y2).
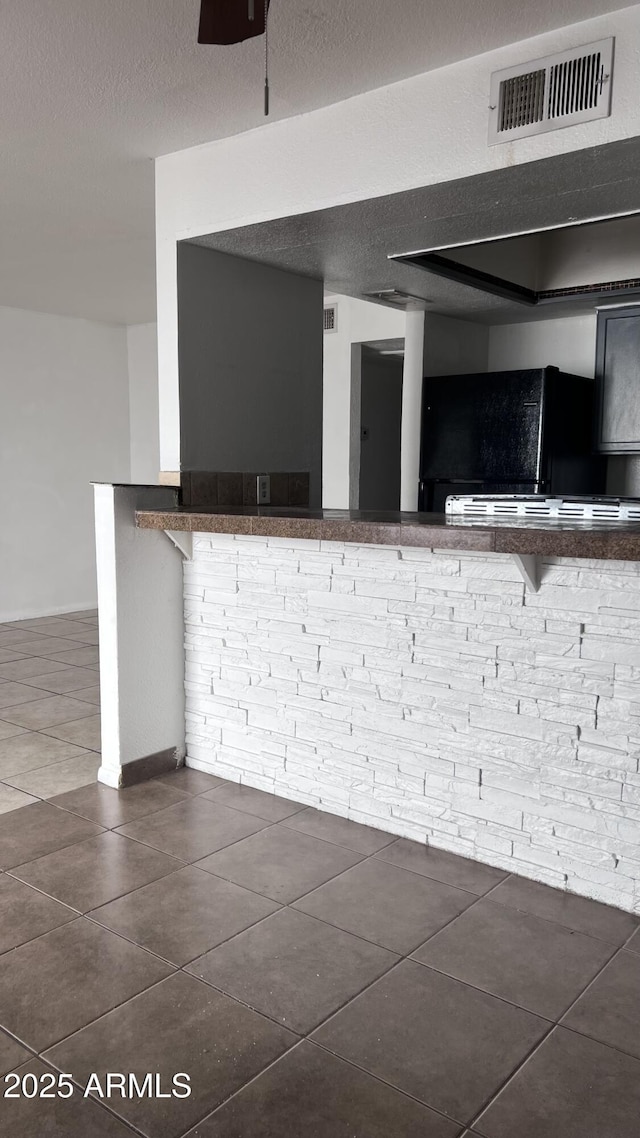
(418, 368, 606, 513)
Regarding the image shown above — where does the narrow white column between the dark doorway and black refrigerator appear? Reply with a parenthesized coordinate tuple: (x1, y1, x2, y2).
(400, 308, 425, 511)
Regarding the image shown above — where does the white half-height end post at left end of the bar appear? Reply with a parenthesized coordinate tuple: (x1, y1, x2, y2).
(95, 485, 184, 786)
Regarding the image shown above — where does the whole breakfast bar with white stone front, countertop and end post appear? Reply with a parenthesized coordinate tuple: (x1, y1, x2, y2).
(96, 486, 640, 913)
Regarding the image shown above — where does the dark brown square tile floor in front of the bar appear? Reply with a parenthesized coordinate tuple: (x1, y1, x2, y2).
(0, 764, 640, 1138)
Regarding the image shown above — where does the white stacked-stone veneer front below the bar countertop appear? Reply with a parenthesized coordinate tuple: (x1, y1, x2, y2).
(184, 534, 640, 912)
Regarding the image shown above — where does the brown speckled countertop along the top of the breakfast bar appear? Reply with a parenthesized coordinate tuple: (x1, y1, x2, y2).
(136, 506, 640, 561)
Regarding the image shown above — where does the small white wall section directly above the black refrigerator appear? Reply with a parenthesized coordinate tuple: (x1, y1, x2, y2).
(489, 312, 596, 376)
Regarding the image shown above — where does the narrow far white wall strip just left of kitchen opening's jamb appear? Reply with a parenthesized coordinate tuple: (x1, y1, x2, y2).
(126, 324, 161, 483)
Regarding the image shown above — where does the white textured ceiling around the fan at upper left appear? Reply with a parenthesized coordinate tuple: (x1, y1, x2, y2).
(0, 0, 624, 322)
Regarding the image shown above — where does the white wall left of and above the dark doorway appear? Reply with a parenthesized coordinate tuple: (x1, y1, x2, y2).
(322, 295, 407, 510)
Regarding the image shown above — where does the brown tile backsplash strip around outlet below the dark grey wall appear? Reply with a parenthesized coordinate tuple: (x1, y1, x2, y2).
(181, 470, 309, 510)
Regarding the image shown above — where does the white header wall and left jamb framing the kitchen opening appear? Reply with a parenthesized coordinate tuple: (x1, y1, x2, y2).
(156, 5, 640, 470)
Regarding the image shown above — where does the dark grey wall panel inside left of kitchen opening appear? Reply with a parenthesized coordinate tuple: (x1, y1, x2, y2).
(178, 242, 323, 506)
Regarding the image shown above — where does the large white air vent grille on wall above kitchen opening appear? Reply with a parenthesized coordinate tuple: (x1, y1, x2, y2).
(489, 36, 614, 146)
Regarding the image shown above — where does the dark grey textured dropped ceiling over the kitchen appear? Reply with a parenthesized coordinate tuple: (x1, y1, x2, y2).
(192, 138, 640, 323)
